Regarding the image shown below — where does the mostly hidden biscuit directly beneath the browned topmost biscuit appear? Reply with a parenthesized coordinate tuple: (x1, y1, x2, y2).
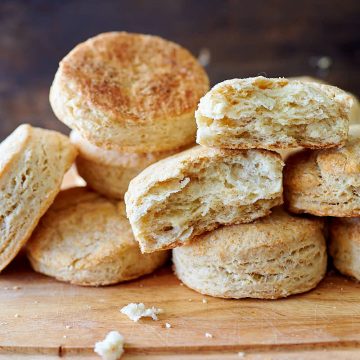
(70, 131, 188, 199)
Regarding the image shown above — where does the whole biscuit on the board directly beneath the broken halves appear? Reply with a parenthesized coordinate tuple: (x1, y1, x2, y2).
(173, 208, 327, 299)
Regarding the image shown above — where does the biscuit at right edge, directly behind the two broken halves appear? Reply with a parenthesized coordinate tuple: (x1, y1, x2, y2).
(284, 125, 360, 217)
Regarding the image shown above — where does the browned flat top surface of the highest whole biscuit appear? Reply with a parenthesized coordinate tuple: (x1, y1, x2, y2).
(58, 32, 209, 121)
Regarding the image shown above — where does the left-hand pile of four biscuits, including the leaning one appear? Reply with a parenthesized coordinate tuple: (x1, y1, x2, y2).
(0, 32, 209, 286)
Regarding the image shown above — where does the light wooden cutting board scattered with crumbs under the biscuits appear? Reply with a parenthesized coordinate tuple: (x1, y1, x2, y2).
(0, 255, 360, 360)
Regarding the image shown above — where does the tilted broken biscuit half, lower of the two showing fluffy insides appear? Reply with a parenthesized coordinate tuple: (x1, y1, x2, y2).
(125, 146, 283, 252)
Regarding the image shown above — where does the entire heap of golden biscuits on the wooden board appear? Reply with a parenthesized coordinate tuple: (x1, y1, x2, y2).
(0, 32, 360, 299)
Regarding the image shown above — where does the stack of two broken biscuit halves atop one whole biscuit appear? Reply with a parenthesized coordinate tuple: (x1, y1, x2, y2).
(125, 77, 351, 299)
